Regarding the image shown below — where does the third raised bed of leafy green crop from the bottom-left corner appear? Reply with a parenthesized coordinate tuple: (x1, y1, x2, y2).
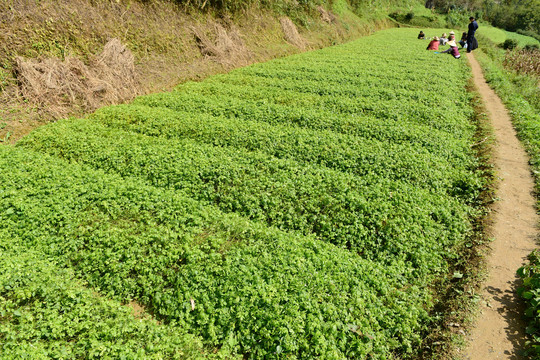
(20, 120, 470, 276)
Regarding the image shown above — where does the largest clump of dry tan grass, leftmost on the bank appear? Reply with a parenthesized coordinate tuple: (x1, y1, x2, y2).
(15, 39, 140, 118)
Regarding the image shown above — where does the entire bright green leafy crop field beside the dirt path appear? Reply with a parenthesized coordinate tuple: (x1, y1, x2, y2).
(0, 29, 486, 359)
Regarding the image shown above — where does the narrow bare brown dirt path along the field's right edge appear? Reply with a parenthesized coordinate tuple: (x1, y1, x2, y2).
(464, 54, 539, 360)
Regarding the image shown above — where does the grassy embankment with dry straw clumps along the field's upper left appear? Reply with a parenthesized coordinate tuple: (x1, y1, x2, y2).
(0, 0, 418, 143)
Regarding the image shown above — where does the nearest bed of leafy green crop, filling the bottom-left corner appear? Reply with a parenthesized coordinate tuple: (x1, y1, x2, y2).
(0, 243, 216, 359)
